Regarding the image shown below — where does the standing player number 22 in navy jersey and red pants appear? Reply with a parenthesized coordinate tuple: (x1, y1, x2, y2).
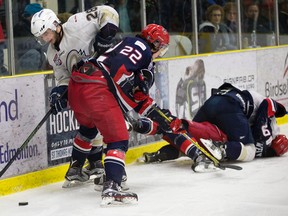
(68, 24, 173, 205)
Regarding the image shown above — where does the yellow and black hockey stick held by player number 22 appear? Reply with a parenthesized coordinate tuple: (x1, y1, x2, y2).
(152, 106, 242, 170)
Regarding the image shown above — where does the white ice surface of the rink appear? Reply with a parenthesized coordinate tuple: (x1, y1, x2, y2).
(0, 125, 288, 216)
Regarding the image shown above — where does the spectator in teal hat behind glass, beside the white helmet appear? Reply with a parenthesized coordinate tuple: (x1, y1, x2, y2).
(13, 3, 46, 73)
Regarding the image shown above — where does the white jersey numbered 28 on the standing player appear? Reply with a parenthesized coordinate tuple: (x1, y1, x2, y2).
(47, 5, 119, 86)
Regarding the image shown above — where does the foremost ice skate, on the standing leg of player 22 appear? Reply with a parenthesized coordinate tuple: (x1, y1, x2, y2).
(100, 180, 138, 207)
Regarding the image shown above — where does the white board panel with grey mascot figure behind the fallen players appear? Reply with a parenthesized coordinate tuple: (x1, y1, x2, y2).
(168, 51, 257, 118)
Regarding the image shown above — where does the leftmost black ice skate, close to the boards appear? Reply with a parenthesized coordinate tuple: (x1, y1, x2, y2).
(62, 161, 89, 188)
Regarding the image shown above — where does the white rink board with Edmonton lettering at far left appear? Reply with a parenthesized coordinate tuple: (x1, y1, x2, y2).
(0, 75, 47, 178)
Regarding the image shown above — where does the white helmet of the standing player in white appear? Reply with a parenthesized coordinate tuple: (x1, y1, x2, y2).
(31, 9, 61, 38)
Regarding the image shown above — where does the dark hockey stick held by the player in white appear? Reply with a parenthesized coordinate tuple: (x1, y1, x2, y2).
(0, 89, 67, 178)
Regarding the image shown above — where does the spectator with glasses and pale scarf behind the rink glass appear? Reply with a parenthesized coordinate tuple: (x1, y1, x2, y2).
(199, 5, 236, 53)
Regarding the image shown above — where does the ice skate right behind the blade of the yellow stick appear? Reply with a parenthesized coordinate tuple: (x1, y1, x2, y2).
(191, 153, 219, 173)
